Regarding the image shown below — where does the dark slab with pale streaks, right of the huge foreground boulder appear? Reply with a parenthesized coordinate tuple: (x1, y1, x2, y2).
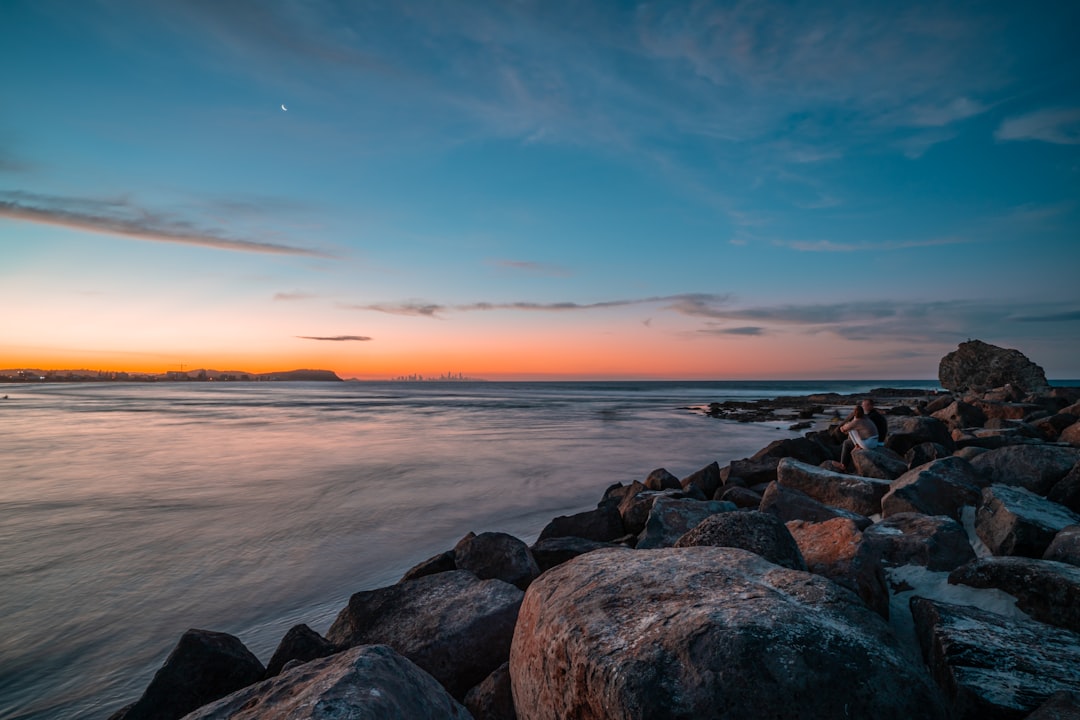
(912, 597, 1080, 720)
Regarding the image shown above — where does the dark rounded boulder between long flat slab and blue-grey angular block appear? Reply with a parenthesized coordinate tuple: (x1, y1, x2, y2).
(881, 457, 983, 520)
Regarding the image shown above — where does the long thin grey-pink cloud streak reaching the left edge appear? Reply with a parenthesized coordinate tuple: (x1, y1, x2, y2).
(0, 191, 330, 258)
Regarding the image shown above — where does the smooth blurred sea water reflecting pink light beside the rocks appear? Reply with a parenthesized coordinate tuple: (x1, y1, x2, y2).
(0, 381, 935, 720)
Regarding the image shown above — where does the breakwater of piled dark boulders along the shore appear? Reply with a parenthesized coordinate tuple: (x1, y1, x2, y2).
(107, 343, 1080, 720)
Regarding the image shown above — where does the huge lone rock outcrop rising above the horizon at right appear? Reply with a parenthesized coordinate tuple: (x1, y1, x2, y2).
(937, 340, 1049, 393)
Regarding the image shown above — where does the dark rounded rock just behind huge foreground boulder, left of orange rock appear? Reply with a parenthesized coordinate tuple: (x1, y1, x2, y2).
(675, 512, 807, 570)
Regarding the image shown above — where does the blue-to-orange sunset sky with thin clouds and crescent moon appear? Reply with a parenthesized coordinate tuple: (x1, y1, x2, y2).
(0, 0, 1080, 380)
